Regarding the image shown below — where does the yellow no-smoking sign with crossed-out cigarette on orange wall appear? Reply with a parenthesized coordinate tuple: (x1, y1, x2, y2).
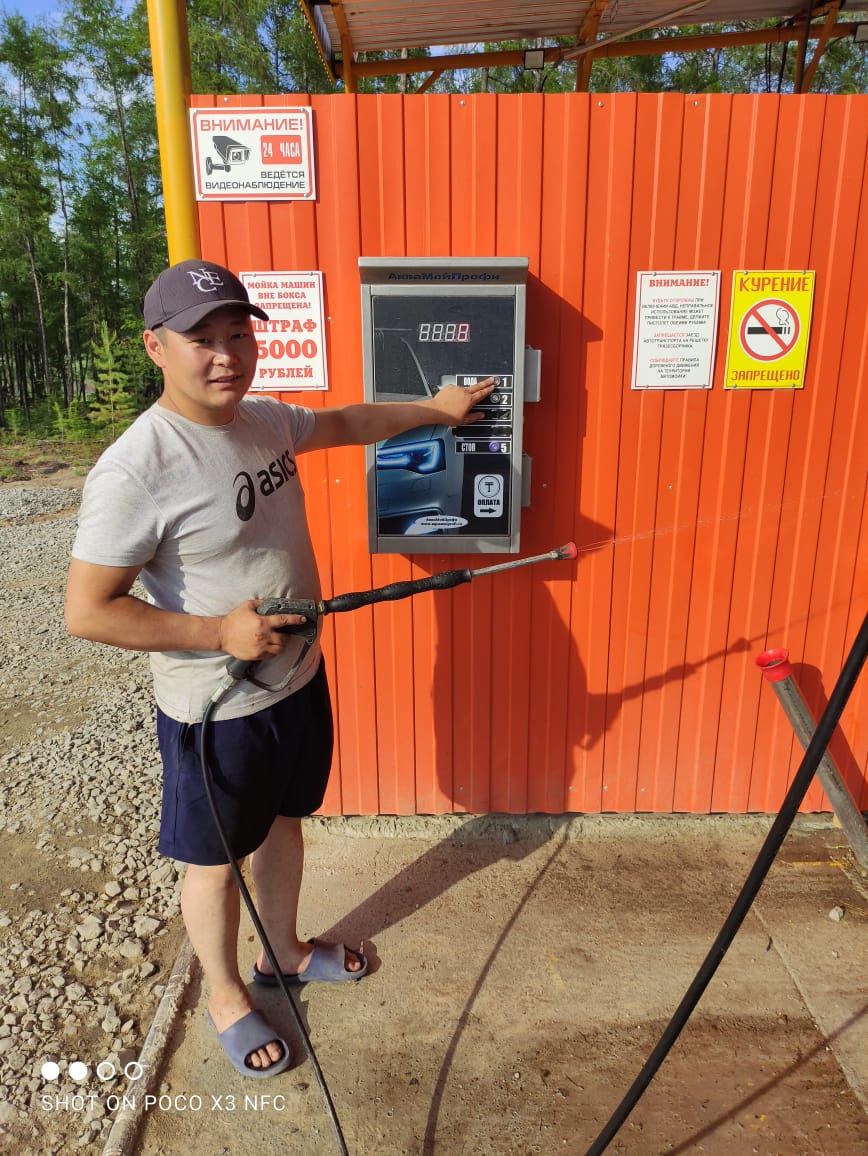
(724, 269, 814, 390)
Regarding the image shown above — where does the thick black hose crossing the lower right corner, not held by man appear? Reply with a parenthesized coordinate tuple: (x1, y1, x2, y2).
(586, 615, 868, 1156)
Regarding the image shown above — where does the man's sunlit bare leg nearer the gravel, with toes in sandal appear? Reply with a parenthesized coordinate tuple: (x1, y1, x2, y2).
(180, 864, 283, 1068)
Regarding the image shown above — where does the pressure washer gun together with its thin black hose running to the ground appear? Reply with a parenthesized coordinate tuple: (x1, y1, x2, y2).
(199, 542, 578, 1156)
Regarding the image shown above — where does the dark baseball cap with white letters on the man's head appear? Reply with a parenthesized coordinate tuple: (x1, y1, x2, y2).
(143, 259, 268, 333)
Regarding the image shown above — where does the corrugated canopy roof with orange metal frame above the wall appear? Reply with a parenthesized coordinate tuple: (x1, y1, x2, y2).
(302, 0, 868, 91)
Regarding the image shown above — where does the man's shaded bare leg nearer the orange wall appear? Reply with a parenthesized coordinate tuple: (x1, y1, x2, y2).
(251, 815, 362, 976)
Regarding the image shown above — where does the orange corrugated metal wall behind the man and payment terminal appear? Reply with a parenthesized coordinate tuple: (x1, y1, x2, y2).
(193, 94, 868, 814)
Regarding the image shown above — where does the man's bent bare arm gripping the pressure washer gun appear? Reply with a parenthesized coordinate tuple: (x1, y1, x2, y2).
(64, 558, 305, 661)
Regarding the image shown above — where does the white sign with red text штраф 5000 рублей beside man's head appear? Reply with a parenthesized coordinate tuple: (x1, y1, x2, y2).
(238, 271, 328, 393)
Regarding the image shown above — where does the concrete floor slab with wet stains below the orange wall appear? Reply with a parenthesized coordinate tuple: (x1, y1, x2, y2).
(105, 816, 868, 1156)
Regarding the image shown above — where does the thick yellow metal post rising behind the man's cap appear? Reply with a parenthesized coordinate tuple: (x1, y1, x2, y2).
(148, 0, 202, 265)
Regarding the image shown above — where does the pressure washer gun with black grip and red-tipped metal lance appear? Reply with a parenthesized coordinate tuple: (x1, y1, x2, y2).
(215, 542, 579, 698)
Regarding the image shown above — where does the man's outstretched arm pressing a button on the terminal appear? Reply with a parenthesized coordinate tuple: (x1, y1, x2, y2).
(301, 377, 495, 453)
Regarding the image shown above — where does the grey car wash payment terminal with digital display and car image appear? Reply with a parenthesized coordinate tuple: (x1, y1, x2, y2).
(358, 257, 528, 554)
